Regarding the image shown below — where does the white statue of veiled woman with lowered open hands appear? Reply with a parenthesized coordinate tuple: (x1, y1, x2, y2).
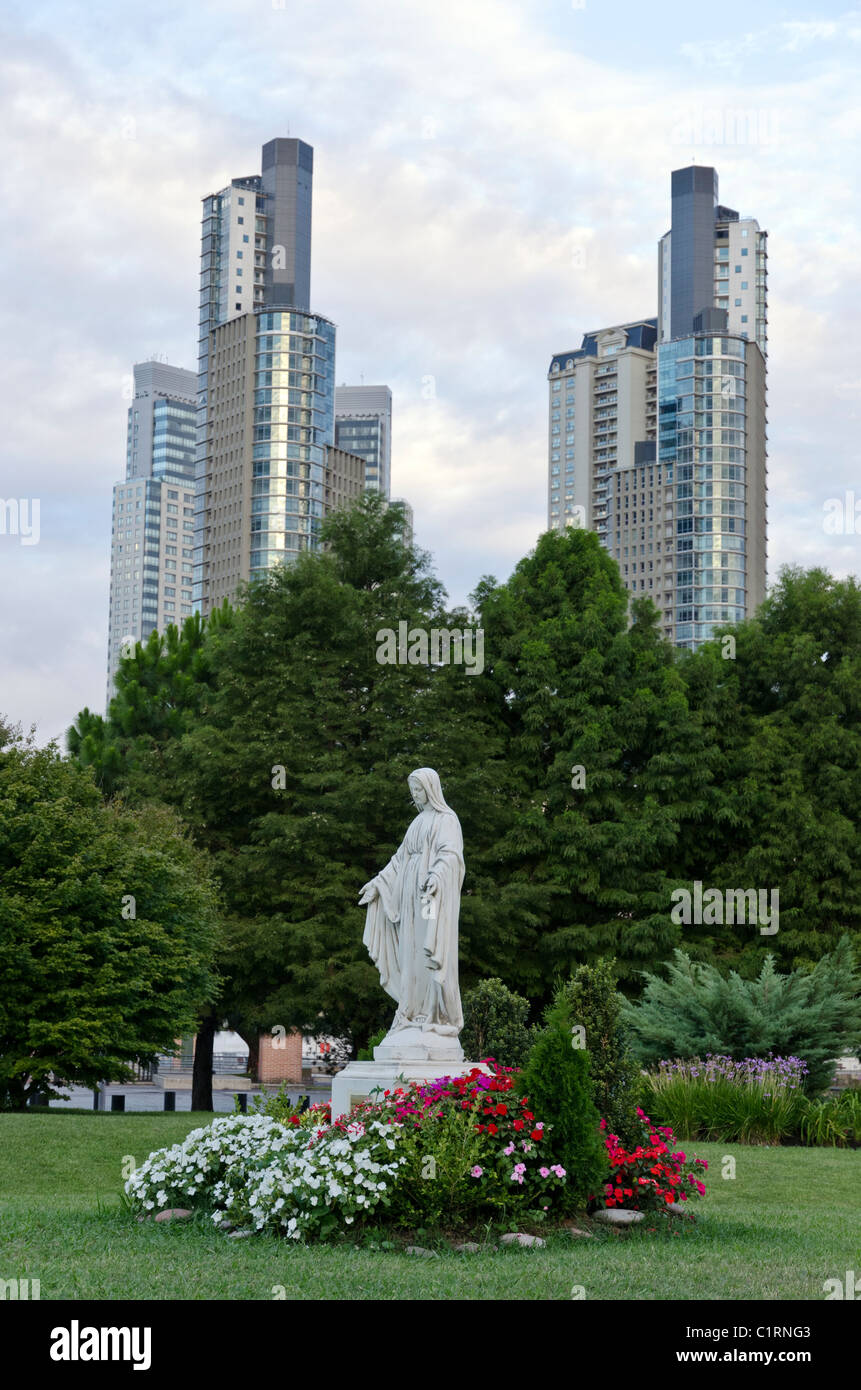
(359, 767, 463, 1061)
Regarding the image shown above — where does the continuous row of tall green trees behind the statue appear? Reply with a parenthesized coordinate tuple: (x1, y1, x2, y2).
(70, 495, 861, 1055)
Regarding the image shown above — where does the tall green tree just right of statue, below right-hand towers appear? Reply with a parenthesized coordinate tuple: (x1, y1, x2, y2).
(477, 530, 714, 999)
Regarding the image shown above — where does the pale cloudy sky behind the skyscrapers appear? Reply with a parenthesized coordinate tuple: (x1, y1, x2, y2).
(0, 0, 861, 741)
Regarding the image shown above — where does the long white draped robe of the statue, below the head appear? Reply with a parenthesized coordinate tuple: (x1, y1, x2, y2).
(363, 806, 463, 1036)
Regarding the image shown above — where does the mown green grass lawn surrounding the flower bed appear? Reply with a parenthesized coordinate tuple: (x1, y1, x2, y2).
(0, 1113, 861, 1301)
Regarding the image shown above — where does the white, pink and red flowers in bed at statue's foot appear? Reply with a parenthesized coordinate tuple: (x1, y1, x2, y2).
(125, 1069, 704, 1240)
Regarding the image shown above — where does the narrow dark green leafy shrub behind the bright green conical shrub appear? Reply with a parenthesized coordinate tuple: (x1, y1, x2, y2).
(563, 959, 641, 1140)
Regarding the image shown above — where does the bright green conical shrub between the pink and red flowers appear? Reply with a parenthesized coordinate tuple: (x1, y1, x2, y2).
(516, 987, 606, 1205)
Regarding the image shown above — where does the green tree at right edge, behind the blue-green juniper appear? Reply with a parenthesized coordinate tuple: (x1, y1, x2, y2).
(676, 567, 861, 974)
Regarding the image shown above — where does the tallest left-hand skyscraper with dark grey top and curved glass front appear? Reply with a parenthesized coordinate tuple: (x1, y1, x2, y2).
(193, 139, 363, 613)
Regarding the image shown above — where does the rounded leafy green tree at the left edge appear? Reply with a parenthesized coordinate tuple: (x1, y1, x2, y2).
(0, 731, 217, 1108)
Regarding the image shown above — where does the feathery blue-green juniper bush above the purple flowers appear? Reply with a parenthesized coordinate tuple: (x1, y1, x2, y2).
(623, 935, 861, 1094)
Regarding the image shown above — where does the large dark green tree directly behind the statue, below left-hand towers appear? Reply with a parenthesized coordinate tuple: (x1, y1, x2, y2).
(70, 495, 515, 1044)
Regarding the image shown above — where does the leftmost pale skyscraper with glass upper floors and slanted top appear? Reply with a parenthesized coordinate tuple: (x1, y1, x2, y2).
(107, 361, 198, 701)
